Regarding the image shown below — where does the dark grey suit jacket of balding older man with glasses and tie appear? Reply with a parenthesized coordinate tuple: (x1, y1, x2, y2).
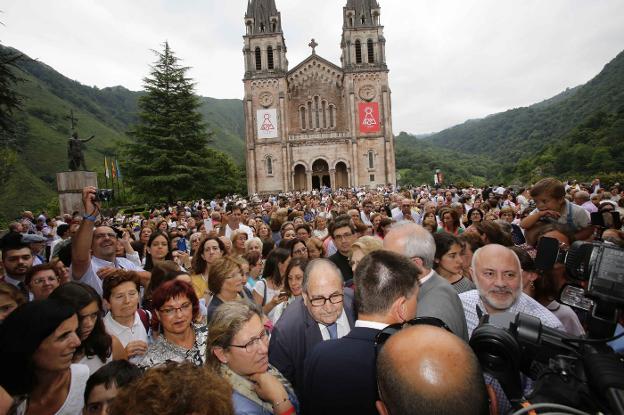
(269, 288, 356, 402)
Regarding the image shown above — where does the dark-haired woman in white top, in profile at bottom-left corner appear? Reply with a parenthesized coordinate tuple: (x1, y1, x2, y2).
(0, 299, 89, 415)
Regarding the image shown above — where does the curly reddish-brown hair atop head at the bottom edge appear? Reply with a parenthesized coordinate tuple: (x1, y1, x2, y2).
(110, 362, 234, 415)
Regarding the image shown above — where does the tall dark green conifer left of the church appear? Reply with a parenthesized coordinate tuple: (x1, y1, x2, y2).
(125, 42, 239, 202)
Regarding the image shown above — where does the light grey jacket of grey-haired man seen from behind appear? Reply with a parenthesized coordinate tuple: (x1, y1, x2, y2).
(416, 271, 468, 342)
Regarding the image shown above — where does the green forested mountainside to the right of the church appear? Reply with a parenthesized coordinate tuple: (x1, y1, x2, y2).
(396, 52, 624, 183)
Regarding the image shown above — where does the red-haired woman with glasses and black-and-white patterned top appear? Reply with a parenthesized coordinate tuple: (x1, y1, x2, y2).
(139, 280, 207, 368)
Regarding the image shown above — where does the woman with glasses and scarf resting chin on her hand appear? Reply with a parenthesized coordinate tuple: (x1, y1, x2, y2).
(207, 301, 299, 415)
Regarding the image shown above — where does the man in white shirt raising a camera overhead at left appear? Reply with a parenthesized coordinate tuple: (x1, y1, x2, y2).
(71, 186, 151, 296)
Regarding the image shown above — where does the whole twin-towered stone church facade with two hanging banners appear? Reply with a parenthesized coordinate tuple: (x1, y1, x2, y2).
(243, 0, 396, 194)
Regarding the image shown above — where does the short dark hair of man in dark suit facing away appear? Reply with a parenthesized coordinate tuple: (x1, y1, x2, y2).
(354, 250, 419, 314)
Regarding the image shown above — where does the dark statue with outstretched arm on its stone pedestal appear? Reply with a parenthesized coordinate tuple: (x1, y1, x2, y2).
(56, 110, 97, 215)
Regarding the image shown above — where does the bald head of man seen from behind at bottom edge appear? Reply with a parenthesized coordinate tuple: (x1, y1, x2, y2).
(376, 324, 489, 415)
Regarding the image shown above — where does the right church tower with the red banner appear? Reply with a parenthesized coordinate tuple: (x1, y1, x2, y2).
(340, 0, 396, 185)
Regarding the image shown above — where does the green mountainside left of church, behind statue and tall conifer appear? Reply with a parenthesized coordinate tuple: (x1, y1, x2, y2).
(0, 46, 245, 229)
